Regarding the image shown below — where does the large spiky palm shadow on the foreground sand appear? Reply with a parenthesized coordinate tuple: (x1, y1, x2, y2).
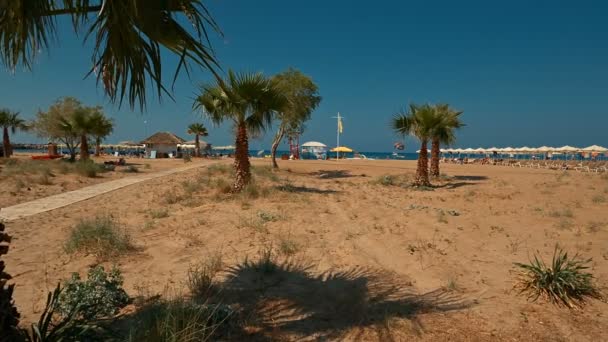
(221, 258, 473, 341)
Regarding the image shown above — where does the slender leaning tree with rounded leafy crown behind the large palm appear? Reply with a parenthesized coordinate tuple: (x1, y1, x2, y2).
(270, 68, 321, 169)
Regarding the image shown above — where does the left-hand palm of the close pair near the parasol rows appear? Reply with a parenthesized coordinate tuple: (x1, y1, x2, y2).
(391, 104, 439, 186)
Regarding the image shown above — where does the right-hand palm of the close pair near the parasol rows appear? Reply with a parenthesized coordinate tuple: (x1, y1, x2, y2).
(431, 104, 464, 177)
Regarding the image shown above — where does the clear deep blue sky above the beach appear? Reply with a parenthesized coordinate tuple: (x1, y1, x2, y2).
(0, 0, 608, 152)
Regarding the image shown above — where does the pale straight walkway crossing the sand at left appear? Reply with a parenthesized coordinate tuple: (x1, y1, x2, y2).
(0, 164, 214, 221)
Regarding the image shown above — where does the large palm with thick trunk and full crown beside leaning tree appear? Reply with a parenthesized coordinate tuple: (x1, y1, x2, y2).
(193, 70, 287, 192)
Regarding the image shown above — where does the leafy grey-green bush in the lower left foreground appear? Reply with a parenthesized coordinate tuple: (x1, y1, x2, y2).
(57, 266, 129, 321)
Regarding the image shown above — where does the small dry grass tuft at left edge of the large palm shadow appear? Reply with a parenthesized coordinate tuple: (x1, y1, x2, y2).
(188, 254, 223, 302)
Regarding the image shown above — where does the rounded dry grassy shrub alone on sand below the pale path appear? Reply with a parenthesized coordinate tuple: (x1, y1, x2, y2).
(65, 216, 133, 259)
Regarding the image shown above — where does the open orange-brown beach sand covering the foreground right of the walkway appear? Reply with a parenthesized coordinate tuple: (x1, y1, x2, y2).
(1, 160, 608, 341)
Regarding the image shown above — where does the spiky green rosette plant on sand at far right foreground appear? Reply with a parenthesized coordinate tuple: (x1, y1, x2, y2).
(515, 246, 601, 308)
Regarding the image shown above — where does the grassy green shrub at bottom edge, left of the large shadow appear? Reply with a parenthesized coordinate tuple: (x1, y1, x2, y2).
(126, 299, 234, 342)
